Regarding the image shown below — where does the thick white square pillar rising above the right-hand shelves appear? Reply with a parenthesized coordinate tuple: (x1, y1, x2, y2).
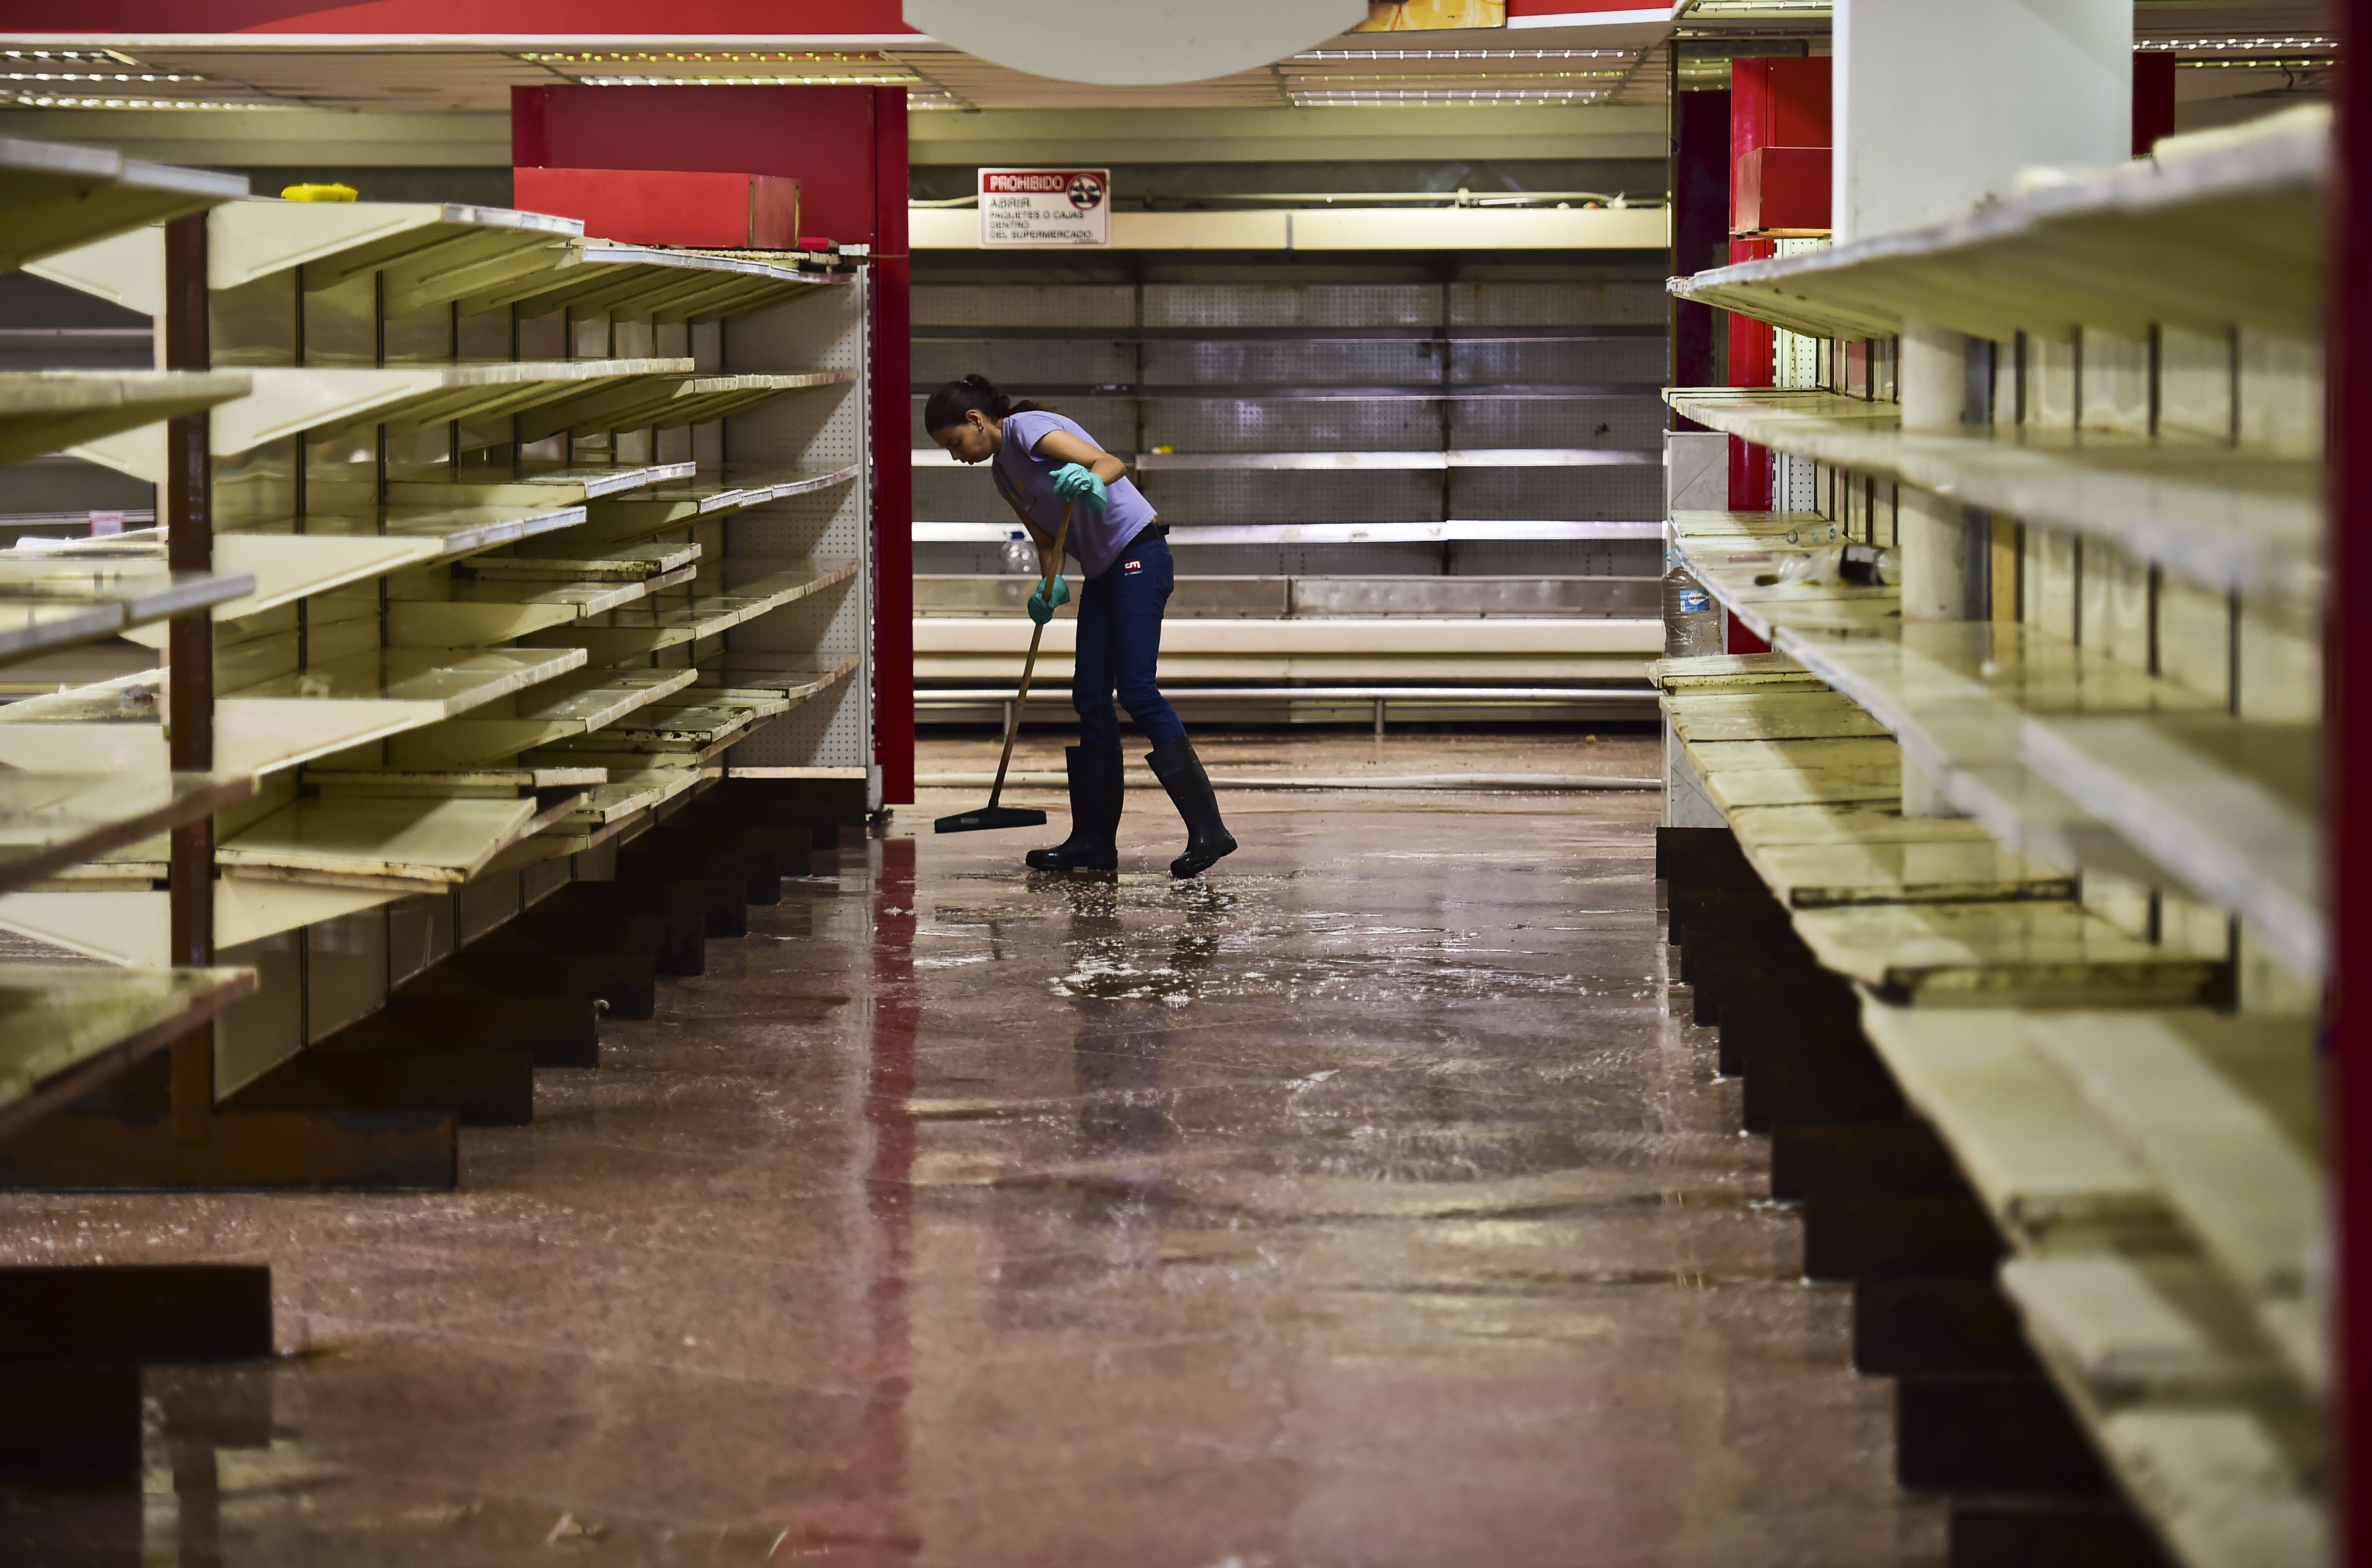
(1834, 0, 2132, 242)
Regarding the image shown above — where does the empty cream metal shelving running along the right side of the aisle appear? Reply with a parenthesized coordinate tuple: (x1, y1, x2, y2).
(1660, 109, 2332, 1568)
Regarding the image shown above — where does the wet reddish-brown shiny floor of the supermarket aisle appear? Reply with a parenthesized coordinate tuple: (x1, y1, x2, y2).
(0, 738, 1940, 1568)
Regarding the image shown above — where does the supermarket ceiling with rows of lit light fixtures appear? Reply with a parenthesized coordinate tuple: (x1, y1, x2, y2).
(0, 0, 2334, 123)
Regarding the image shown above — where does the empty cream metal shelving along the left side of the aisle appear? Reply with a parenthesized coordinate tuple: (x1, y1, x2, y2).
(0, 202, 873, 1096)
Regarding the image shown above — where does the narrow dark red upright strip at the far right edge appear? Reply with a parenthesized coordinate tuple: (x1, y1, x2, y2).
(2325, 0, 2372, 1568)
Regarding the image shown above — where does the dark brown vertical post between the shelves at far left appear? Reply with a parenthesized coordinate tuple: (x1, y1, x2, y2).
(164, 213, 214, 1143)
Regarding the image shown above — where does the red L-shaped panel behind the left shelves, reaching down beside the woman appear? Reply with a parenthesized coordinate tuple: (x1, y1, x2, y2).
(510, 85, 913, 804)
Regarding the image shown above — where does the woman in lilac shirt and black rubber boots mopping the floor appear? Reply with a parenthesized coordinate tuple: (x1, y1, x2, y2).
(923, 375, 1236, 878)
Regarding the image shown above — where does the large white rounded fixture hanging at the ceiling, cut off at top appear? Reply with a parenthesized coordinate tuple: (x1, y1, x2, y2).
(906, 0, 1366, 88)
